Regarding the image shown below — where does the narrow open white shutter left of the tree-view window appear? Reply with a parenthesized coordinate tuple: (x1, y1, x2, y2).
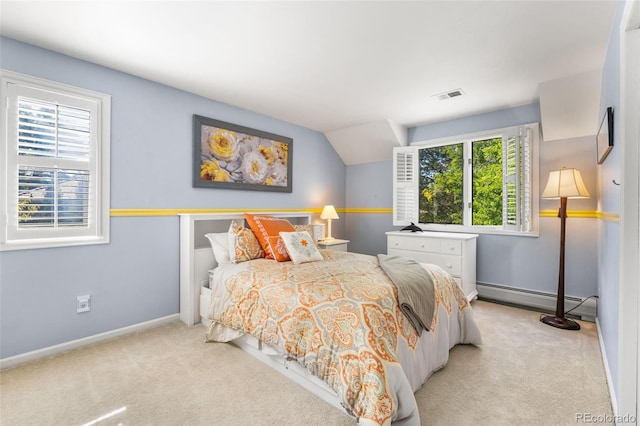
(393, 146, 419, 226)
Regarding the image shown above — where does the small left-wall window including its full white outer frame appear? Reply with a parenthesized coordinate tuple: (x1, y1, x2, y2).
(0, 70, 111, 250)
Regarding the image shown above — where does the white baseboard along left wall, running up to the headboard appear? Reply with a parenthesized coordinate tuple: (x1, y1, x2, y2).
(0, 314, 180, 370)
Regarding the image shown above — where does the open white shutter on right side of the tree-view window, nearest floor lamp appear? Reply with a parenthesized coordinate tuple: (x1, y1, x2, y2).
(502, 126, 532, 232)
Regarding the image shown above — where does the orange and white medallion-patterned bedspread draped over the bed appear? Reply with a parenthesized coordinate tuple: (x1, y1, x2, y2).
(208, 250, 480, 425)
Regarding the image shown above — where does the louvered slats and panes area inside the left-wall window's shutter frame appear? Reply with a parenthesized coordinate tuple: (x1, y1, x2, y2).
(17, 96, 95, 229)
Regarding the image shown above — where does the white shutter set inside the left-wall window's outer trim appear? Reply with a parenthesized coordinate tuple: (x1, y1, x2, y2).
(7, 84, 98, 240)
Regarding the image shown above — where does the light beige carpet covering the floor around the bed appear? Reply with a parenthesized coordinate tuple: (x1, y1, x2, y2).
(0, 301, 612, 426)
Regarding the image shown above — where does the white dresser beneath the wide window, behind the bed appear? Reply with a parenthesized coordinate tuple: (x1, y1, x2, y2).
(387, 231, 478, 301)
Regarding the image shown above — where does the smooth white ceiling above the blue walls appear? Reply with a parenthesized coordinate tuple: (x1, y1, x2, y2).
(0, 0, 616, 161)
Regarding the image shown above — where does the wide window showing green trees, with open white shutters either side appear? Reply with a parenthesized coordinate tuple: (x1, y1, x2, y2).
(393, 124, 538, 234)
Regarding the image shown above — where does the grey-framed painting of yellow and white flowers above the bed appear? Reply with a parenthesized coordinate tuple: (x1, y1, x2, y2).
(193, 114, 293, 192)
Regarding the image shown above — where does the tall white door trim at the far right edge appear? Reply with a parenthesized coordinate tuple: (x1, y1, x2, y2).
(609, 1, 640, 424)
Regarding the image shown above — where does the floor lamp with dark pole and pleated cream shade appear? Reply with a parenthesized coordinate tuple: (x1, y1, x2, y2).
(540, 167, 589, 330)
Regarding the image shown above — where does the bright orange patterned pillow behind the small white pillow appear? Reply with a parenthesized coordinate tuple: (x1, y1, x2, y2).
(244, 213, 295, 262)
